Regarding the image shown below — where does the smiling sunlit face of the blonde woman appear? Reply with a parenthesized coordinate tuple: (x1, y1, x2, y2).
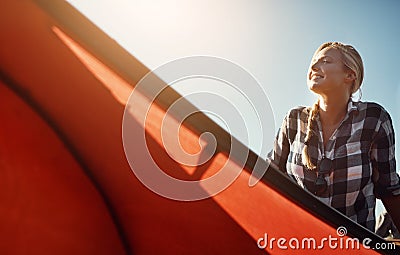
(307, 48, 349, 95)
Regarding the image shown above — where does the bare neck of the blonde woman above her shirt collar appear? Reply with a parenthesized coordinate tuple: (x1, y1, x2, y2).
(319, 96, 349, 125)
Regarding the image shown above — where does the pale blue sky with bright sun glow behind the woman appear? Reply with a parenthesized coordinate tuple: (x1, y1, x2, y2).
(68, 0, 400, 215)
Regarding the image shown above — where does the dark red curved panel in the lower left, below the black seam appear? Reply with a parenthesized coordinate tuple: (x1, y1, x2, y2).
(0, 82, 125, 254)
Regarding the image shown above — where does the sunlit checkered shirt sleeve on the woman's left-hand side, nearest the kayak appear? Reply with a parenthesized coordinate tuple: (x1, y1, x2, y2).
(267, 115, 290, 173)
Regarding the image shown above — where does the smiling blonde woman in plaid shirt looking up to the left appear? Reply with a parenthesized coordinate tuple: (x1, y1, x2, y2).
(269, 42, 400, 231)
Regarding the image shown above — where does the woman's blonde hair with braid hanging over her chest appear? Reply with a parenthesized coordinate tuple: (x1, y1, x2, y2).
(302, 42, 364, 169)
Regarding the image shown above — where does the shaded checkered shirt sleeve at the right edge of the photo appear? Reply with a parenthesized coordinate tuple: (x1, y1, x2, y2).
(370, 109, 400, 198)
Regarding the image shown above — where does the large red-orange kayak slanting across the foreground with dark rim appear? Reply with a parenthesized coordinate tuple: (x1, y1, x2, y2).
(0, 0, 399, 255)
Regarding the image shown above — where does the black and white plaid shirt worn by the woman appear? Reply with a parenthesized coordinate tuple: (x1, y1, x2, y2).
(268, 100, 400, 231)
